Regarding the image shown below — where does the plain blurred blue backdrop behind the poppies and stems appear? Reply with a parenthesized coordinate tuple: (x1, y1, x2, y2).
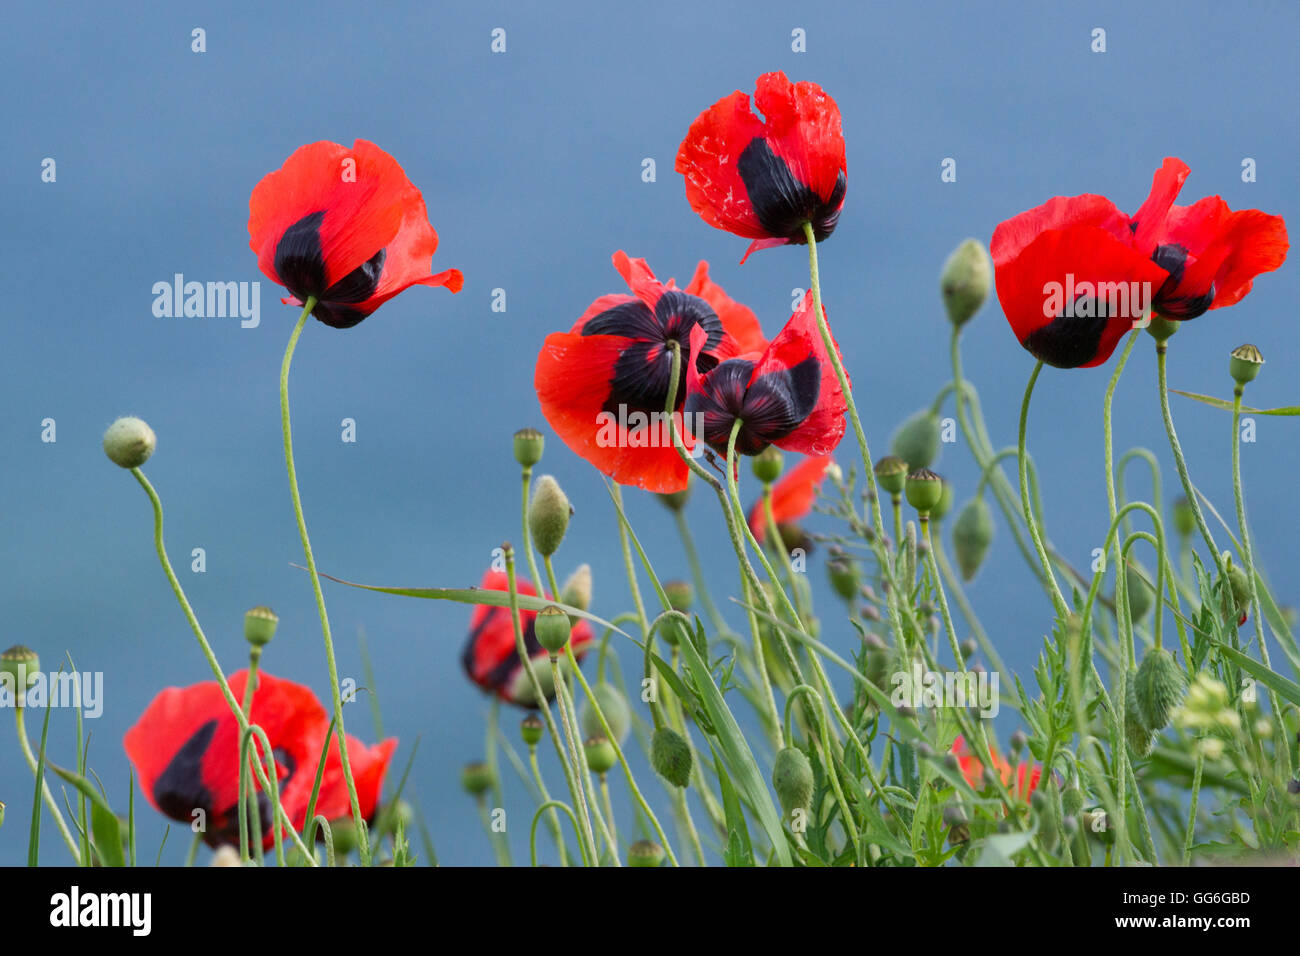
(0, 0, 1300, 864)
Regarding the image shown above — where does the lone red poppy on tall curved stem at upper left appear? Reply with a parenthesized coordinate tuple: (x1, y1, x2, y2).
(248, 139, 463, 329)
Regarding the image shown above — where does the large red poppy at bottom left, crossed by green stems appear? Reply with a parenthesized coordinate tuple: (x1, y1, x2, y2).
(124, 671, 398, 847)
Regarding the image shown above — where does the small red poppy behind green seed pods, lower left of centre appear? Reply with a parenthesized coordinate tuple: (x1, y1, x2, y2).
(460, 571, 594, 708)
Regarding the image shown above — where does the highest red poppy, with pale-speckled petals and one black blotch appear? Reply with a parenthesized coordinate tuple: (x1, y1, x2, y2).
(677, 73, 848, 263)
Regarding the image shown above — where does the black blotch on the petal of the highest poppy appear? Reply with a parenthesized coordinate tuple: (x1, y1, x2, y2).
(736, 137, 848, 242)
